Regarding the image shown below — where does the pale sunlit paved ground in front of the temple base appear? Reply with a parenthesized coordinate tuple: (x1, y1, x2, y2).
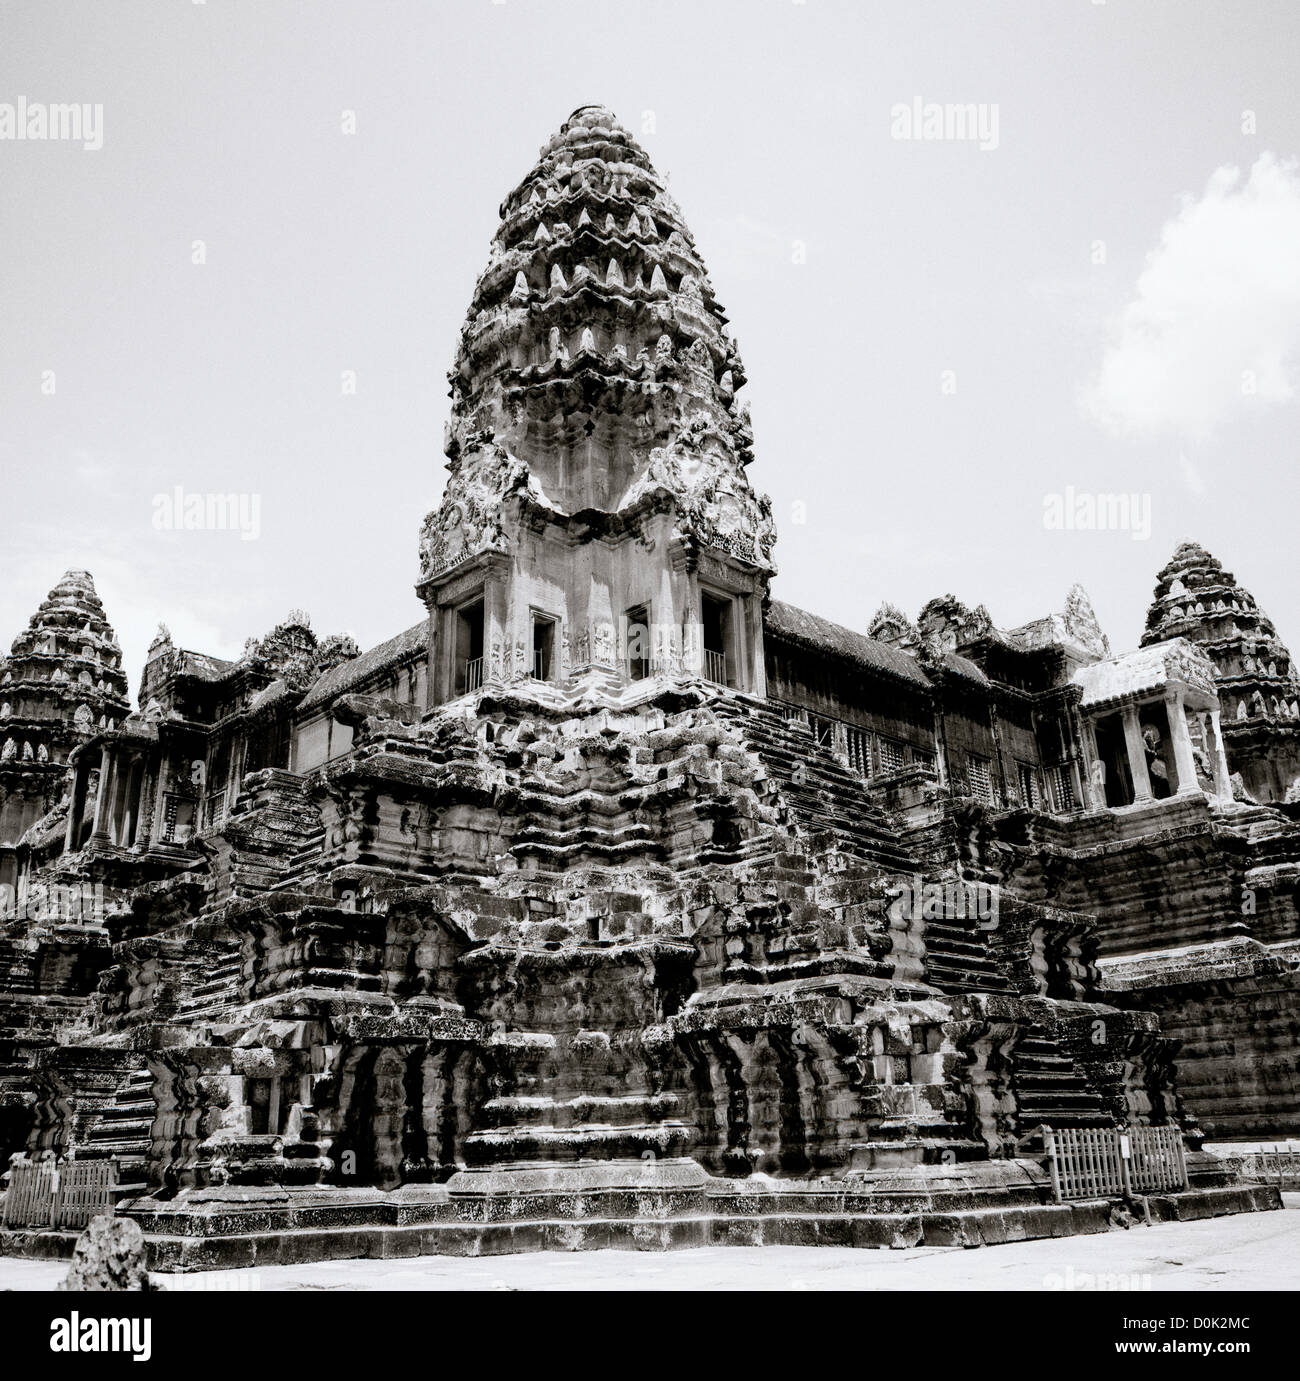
(0, 1195, 1300, 1290)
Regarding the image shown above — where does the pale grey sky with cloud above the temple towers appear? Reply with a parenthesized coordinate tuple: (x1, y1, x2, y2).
(0, 0, 1300, 693)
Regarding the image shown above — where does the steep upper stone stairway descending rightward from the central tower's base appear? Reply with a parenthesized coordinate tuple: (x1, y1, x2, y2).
(716, 697, 920, 873)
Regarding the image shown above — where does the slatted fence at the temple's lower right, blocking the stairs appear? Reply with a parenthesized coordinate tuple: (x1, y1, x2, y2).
(1043, 1127, 1187, 1203)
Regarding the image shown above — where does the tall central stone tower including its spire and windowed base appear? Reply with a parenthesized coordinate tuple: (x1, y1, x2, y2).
(417, 106, 775, 704)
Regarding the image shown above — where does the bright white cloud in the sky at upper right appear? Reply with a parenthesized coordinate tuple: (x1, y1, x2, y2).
(1083, 153, 1300, 439)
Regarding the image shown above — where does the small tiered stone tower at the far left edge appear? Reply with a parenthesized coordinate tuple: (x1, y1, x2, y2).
(0, 570, 130, 884)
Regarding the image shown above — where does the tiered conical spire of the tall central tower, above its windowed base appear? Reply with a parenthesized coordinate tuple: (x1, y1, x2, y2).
(426, 105, 775, 585)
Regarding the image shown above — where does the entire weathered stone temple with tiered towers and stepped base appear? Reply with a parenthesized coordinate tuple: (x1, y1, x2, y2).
(0, 106, 1300, 1269)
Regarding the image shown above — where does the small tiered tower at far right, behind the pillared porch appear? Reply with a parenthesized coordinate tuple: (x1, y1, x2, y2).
(1143, 541, 1300, 801)
